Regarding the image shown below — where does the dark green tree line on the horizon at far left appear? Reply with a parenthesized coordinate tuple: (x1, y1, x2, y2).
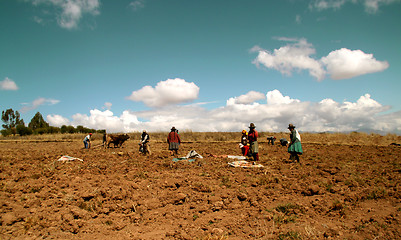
(0, 108, 105, 136)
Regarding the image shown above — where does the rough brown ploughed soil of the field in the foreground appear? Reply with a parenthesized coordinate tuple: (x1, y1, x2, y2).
(0, 136, 401, 239)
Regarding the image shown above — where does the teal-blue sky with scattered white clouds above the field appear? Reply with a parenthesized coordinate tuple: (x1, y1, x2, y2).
(0, 0, 401, 134)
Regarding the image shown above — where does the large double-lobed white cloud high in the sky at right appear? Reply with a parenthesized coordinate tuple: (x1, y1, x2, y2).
(252, 38, 389, 81)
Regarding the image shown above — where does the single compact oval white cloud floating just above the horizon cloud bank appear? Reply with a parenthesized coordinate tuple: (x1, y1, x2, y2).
(127, 78, 199, 107)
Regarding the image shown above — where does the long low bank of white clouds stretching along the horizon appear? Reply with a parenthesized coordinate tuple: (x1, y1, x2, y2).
(47, 89, 401, 134)
